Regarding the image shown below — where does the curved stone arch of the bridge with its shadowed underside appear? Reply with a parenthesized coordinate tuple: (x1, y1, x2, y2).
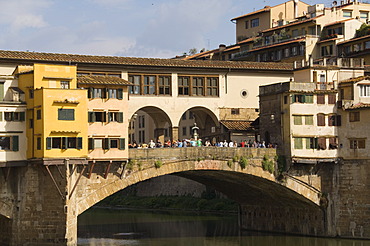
(77, 160, 320, 214)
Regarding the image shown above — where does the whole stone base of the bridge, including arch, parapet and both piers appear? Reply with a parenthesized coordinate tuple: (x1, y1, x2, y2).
(0, 147, 370, 246)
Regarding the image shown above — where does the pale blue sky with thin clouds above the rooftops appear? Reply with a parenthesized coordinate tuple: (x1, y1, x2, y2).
(0, 0, 324, 58)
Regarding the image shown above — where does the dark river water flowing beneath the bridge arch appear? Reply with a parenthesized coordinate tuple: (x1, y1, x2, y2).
(78, 208, 370, 246)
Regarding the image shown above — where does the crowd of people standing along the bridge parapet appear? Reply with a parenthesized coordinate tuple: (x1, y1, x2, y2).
(129, 138, 276, 148)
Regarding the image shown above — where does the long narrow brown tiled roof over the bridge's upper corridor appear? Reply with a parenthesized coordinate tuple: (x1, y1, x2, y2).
(0, 50, 293, 71)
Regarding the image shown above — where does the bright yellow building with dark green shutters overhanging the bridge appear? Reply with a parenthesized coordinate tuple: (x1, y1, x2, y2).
(15, 64, 88, 159)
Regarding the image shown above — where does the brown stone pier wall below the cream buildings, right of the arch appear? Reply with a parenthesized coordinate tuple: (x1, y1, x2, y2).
(323, 160, 370, 238)
